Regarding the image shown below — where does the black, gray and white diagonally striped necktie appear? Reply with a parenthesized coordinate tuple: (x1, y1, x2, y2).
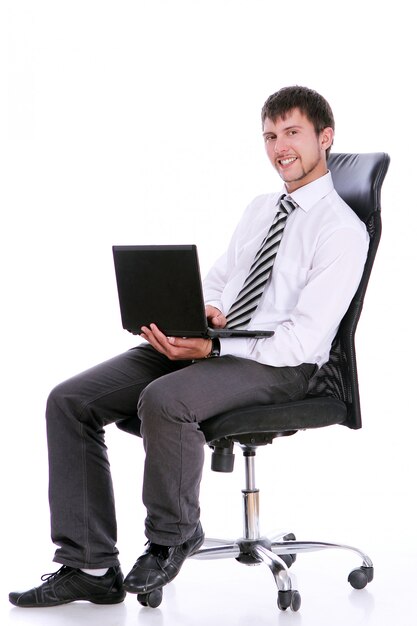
(226, 195, 297, 328)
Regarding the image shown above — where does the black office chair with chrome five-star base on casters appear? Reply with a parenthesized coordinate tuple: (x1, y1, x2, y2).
(117, 153, 389, 611)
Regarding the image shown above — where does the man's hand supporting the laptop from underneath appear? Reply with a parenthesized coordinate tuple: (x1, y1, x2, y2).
(141, 324, 211, 361)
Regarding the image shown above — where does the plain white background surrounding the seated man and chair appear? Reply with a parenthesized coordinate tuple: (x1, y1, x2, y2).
(0, 0, 417, 626)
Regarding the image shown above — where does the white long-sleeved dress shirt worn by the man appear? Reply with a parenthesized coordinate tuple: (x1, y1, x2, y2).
(203, 172, 369, 367)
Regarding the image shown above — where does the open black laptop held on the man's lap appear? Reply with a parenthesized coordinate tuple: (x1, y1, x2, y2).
(113, 245, 274, 337)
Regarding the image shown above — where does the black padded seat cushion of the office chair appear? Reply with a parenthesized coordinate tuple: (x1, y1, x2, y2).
(200, 398, 347, 443)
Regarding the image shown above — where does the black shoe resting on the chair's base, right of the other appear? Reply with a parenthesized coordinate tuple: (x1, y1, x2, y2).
(123, 523, 204, 593)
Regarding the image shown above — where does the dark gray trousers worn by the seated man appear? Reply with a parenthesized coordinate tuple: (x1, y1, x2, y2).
(46, 344, 314, 568)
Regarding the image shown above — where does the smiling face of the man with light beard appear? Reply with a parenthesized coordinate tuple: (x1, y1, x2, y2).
(263, 109, 333, 193)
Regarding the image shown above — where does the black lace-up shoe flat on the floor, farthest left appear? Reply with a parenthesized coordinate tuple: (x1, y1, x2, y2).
(9, 565, 126, 608)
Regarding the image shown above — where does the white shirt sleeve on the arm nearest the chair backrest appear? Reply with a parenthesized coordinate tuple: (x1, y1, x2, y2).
(221, 227, 369, 367)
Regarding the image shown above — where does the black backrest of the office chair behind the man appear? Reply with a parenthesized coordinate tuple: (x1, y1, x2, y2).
(309, 152, 390, 428)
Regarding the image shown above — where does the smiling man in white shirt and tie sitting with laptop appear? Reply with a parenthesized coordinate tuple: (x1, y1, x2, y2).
(10, 86, 368, 607)
